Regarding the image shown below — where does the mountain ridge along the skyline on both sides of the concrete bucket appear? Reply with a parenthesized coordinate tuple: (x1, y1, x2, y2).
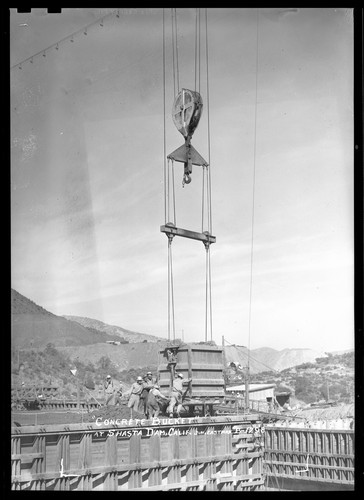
(11, 289, 348, 373)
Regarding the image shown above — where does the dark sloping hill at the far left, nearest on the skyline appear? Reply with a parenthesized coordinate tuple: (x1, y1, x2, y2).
(11, 289, 119, 348)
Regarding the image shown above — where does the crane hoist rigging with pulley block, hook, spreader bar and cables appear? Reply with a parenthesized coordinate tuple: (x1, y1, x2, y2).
(160, 9, 216, 341)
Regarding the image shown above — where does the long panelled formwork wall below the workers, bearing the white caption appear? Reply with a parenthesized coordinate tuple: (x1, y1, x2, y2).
(11, 416, 264, 491)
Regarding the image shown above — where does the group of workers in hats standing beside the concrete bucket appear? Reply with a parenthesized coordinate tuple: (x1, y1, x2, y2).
(104, 372, 191, 418)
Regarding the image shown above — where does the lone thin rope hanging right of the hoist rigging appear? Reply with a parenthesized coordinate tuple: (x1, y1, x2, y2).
(248, 8, 259, 370)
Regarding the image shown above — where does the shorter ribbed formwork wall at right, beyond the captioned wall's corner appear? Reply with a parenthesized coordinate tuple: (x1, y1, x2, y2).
(264, 426, 354, 484)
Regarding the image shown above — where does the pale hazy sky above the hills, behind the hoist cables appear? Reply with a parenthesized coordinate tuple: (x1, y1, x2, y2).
(10, 8, 354, 351)
